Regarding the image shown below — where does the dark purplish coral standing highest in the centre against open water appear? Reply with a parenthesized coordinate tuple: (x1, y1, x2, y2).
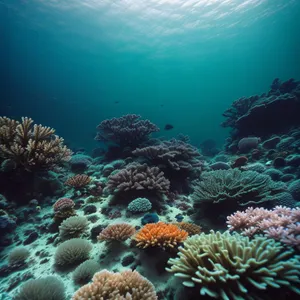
(95, 114, 159, 147)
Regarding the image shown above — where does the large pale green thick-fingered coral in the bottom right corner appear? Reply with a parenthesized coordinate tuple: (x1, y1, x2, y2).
(166, 231, 300, 300)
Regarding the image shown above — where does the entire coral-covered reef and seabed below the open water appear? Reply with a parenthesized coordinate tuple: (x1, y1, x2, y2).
(0, 79, 300, 300)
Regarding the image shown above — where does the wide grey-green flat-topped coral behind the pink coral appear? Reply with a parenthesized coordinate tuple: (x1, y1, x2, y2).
(192, 169, 286, 206)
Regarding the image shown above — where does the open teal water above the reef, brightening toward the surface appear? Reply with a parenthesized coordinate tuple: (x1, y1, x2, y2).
(0, 0, 300, 149)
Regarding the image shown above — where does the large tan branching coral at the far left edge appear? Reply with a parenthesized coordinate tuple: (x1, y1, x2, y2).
(0, 117, 72, 171)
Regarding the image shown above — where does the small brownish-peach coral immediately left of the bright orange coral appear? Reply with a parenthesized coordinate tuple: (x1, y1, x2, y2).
(97, 223, 135, 241)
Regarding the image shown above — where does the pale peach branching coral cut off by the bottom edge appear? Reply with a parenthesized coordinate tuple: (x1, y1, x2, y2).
(72, 270, 157, 300)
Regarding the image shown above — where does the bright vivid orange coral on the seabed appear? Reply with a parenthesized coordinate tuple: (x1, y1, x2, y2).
(133, 222, 188, 249)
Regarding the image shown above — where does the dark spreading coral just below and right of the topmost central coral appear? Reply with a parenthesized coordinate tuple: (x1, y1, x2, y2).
(132, 139, 202, 171)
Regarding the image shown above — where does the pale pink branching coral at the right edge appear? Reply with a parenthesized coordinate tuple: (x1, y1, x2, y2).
(227, 206, 300, 250)
